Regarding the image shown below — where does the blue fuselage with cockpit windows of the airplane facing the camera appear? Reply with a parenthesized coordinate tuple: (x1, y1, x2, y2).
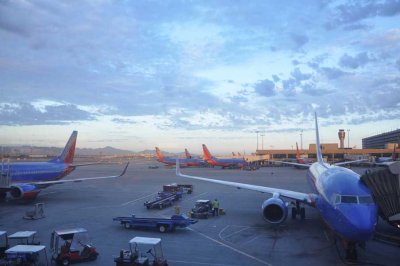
(308, 163, 378, 242)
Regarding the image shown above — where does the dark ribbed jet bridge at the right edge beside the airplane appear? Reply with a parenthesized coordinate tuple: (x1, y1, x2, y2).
(361, 161, 400, 228)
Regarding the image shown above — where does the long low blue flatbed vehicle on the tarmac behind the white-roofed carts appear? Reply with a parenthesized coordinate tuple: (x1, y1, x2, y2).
(113, 214, 197, 233)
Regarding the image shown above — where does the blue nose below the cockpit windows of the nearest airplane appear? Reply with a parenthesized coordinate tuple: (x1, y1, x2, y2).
(342, 204, 377, 241)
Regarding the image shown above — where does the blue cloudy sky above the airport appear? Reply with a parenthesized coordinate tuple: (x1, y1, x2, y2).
(0, 0, 400, 154)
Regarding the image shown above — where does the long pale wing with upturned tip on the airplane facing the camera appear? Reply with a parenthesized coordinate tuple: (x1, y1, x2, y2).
(176, 161, 317, 207)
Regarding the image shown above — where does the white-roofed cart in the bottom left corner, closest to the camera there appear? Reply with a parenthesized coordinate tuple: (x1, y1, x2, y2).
(5, 245, 49, 266)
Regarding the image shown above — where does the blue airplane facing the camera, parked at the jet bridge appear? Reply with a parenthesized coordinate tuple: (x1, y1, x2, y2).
(176, 113, 378, 261)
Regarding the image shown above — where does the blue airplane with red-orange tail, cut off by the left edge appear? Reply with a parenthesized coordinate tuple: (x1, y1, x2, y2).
(0, 131, 129, 199)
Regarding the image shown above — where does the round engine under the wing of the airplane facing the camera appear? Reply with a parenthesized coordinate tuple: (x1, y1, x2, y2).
(262, 196, 288, 224)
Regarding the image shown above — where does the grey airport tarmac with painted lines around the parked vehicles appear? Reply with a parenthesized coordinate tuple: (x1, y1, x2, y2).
(0, 160, 400, 265)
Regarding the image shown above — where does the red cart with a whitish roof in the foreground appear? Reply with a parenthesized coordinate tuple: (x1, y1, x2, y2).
(50, 228, 99, 265)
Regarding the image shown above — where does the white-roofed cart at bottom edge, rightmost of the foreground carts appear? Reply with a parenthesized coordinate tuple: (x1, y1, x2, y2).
(114, 237, 168, 266)
